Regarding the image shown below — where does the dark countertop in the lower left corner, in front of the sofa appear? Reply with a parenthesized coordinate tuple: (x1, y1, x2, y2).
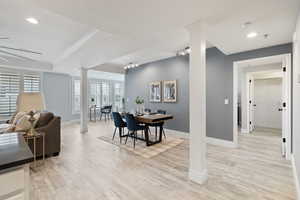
(0, 133, 33, 170)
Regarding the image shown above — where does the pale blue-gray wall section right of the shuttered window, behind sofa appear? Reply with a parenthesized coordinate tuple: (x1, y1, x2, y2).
(42, 72, 80, 121)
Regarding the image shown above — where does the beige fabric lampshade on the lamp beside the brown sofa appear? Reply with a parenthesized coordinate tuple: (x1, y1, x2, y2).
(17, 92, 45, 112)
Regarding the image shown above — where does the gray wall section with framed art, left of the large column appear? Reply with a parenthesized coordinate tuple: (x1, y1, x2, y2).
(125, 57, 189, 131)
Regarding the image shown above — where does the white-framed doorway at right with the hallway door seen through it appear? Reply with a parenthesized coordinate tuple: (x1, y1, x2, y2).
(233, 54, 291, 159)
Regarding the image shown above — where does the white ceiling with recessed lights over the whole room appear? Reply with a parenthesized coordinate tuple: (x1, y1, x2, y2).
(0, 0, 300, 72)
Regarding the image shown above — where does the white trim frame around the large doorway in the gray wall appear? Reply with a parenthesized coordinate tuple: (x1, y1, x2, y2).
(233, 54, 292, 160)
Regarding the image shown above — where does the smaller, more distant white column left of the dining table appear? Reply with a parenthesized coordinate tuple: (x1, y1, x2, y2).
(80, 68, 88, 133)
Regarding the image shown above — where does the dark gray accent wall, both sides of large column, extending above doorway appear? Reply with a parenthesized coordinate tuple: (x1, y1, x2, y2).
(125, 44, 292, 141)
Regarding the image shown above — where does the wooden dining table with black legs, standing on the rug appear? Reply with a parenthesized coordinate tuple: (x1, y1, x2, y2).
(129, 114, 174, 146)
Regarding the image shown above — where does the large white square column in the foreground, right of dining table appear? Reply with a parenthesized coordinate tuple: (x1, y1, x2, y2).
(188, 22, 207, 184)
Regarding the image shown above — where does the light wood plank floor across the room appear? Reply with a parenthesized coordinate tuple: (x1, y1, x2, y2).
(31, 122, 295, 200)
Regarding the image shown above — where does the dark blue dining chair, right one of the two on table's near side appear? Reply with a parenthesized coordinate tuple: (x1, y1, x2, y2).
(125, 114, 146, 148)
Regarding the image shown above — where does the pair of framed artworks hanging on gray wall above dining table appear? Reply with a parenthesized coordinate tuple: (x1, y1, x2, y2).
(149, 80, 177, 103)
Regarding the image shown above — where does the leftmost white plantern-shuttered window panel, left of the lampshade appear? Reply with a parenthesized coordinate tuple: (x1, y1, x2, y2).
(0, 73, 20, 121)
